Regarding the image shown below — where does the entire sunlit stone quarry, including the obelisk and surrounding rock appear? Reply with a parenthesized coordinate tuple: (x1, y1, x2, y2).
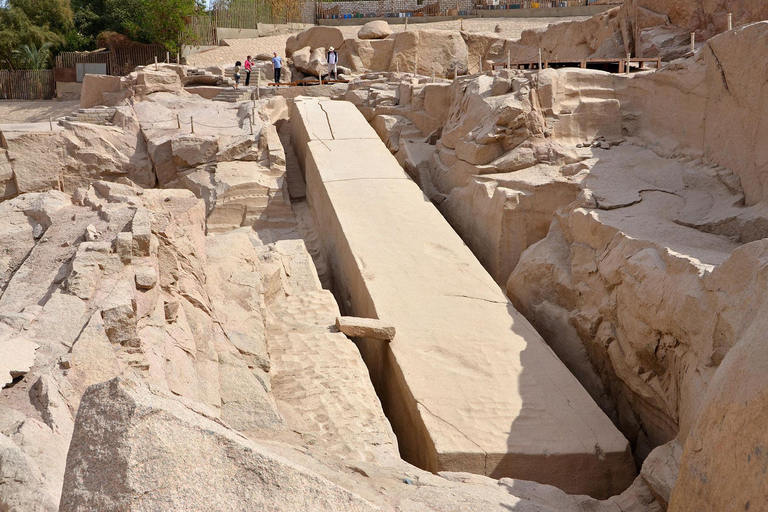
(0, 12, 768, 512)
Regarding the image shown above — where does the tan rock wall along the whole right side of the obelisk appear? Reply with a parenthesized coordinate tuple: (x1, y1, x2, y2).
(346, 20, 766, 510)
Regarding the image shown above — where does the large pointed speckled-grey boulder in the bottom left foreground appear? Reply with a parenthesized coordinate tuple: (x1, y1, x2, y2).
(59, 379, 376, 512)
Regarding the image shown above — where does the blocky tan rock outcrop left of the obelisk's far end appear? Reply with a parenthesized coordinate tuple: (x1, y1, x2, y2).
(0, 65, 287, 198)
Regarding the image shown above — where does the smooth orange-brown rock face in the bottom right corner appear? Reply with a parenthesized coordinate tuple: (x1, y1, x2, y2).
(669, 290, 768, 512)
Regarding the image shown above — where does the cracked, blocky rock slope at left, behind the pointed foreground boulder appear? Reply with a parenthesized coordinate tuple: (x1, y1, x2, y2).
(0, 182, 292, 504)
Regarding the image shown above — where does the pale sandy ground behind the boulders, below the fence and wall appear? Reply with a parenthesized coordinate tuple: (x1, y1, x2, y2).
(187, 17, 588, 67)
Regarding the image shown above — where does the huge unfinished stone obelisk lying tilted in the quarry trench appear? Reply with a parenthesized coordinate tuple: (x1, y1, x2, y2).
(279, 94, 635, 499)
